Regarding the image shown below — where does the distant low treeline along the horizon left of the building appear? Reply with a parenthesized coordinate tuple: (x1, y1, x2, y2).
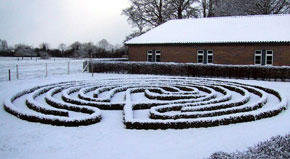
(0, 39, 127, 59)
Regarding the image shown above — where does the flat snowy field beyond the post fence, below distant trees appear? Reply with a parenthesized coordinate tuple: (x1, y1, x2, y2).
(0, 57, 85, 82)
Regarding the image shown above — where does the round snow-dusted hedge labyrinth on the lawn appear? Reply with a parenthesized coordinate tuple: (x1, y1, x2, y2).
(4, 77, 287, 129)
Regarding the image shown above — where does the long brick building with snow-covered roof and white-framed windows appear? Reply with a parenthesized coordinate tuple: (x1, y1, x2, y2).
(126, 14, 290, 66)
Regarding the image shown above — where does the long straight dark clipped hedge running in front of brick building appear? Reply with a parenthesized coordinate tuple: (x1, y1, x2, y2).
(89, 61, 290, 81)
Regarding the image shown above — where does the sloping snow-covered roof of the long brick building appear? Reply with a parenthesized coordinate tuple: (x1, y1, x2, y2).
(126, 14, 290, 45)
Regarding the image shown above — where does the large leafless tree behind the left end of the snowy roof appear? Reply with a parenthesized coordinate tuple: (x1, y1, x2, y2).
(122, 0, 199, 41)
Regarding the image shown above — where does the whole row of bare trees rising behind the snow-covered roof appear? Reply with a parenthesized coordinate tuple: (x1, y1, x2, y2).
(122, 0, 290, 41)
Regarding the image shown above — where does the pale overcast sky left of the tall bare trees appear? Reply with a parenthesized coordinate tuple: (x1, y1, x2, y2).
(0, 0, 132, 48)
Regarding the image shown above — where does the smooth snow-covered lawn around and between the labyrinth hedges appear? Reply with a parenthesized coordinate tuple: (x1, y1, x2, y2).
(0, 73, 290, 159)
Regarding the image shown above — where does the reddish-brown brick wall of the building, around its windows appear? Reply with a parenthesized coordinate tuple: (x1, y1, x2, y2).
(129, 44, 290, 66)
